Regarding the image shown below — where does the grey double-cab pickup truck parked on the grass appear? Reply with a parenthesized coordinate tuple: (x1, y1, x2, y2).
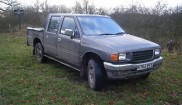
(27, 13, 163, 90)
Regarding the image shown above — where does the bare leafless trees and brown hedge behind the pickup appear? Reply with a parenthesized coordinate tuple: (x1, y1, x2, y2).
(0, 0, 182, 51)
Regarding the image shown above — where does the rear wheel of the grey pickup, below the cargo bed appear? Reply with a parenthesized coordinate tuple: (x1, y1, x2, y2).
(34, 43, 46, 63)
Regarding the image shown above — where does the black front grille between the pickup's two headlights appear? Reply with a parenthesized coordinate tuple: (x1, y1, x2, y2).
(132, 50, 153, 62)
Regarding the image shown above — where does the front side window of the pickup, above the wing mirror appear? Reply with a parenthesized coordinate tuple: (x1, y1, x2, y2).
(60, 17, 76, 34)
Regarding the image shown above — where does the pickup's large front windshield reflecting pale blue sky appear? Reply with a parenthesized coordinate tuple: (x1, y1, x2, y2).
(78, 16, 125, 35)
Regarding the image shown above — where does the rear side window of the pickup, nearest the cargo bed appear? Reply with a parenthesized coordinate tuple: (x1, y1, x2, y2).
(47, 16, 60, 33)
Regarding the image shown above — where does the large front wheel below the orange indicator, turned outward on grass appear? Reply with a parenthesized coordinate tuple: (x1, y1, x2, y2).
(87, 59, 104, 90)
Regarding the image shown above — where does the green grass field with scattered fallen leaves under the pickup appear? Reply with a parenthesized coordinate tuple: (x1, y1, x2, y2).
(0, 35, 182, 105)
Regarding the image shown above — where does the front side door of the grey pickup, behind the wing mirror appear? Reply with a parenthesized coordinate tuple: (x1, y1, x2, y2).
(57, 17, 80, 66)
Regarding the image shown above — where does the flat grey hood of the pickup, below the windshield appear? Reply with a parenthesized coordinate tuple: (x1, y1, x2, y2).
(85, 34, 159, 52)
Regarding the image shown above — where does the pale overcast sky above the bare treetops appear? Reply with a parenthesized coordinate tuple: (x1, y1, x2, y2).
(17, 0, 182, 8)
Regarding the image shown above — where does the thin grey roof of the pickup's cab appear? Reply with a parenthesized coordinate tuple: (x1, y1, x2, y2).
(49, 13, 109, 17)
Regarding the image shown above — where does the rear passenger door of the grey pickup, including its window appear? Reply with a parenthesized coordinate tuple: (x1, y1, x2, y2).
(44, 16, 61, 57)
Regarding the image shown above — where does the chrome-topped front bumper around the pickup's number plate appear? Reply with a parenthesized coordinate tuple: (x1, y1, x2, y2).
(104, 57, 163, 79)
